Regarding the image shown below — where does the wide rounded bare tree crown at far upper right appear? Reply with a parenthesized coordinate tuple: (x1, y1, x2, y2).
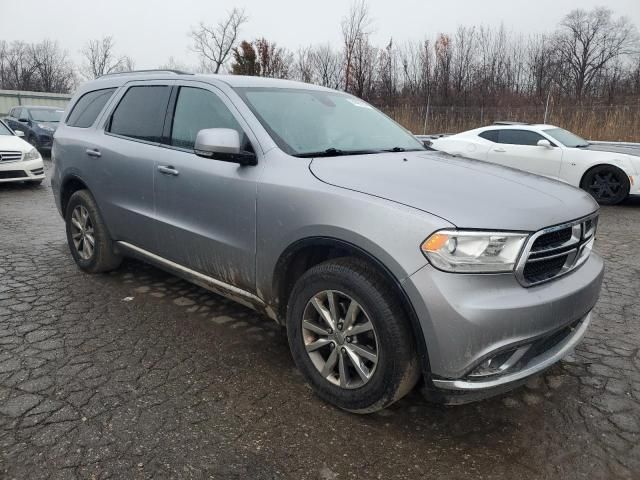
(555, 8, 637, 99)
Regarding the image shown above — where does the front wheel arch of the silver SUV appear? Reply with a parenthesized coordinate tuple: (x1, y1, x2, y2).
(272, 237, 431, 374)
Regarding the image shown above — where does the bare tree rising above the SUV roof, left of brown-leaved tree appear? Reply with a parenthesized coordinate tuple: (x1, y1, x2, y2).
(191, 8, 248, 73)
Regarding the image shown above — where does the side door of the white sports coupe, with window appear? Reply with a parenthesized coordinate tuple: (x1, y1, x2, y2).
(484, 129, 562, 178)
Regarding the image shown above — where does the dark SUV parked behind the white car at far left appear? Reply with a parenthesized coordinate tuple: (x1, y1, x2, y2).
(6, 106, 64, 150)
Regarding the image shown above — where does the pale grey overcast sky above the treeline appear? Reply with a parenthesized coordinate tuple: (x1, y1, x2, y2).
(0, 0, 640, 68)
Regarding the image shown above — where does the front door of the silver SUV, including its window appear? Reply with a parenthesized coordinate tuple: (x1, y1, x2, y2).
(154, 82, 263, 291)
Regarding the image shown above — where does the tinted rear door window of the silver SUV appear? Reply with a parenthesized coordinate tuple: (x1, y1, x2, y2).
(107, 85, 171, 142)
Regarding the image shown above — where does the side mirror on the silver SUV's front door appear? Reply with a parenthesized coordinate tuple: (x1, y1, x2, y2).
(193, 128, 258, 165)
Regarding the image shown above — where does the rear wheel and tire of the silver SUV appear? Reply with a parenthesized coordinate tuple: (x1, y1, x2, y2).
(65, 190, 122, 273)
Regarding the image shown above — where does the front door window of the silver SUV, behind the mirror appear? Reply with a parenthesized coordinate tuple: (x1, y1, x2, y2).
(170, 87, 246, 149)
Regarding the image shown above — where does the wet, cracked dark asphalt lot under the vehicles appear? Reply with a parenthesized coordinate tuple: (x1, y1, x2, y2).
(0, 162, 640, 480)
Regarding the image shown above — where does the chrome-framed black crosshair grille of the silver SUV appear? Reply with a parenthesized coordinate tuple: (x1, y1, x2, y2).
(516, 214, 598, 287)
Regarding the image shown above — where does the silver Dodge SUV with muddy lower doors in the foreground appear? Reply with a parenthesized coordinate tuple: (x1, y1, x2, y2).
(52, 72, 603, 413)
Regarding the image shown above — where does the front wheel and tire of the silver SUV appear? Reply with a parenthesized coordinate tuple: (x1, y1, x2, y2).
(287, 257, 420, 413)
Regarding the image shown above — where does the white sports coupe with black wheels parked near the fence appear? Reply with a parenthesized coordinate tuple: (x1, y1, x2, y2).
(421, 122, 640, 205)
